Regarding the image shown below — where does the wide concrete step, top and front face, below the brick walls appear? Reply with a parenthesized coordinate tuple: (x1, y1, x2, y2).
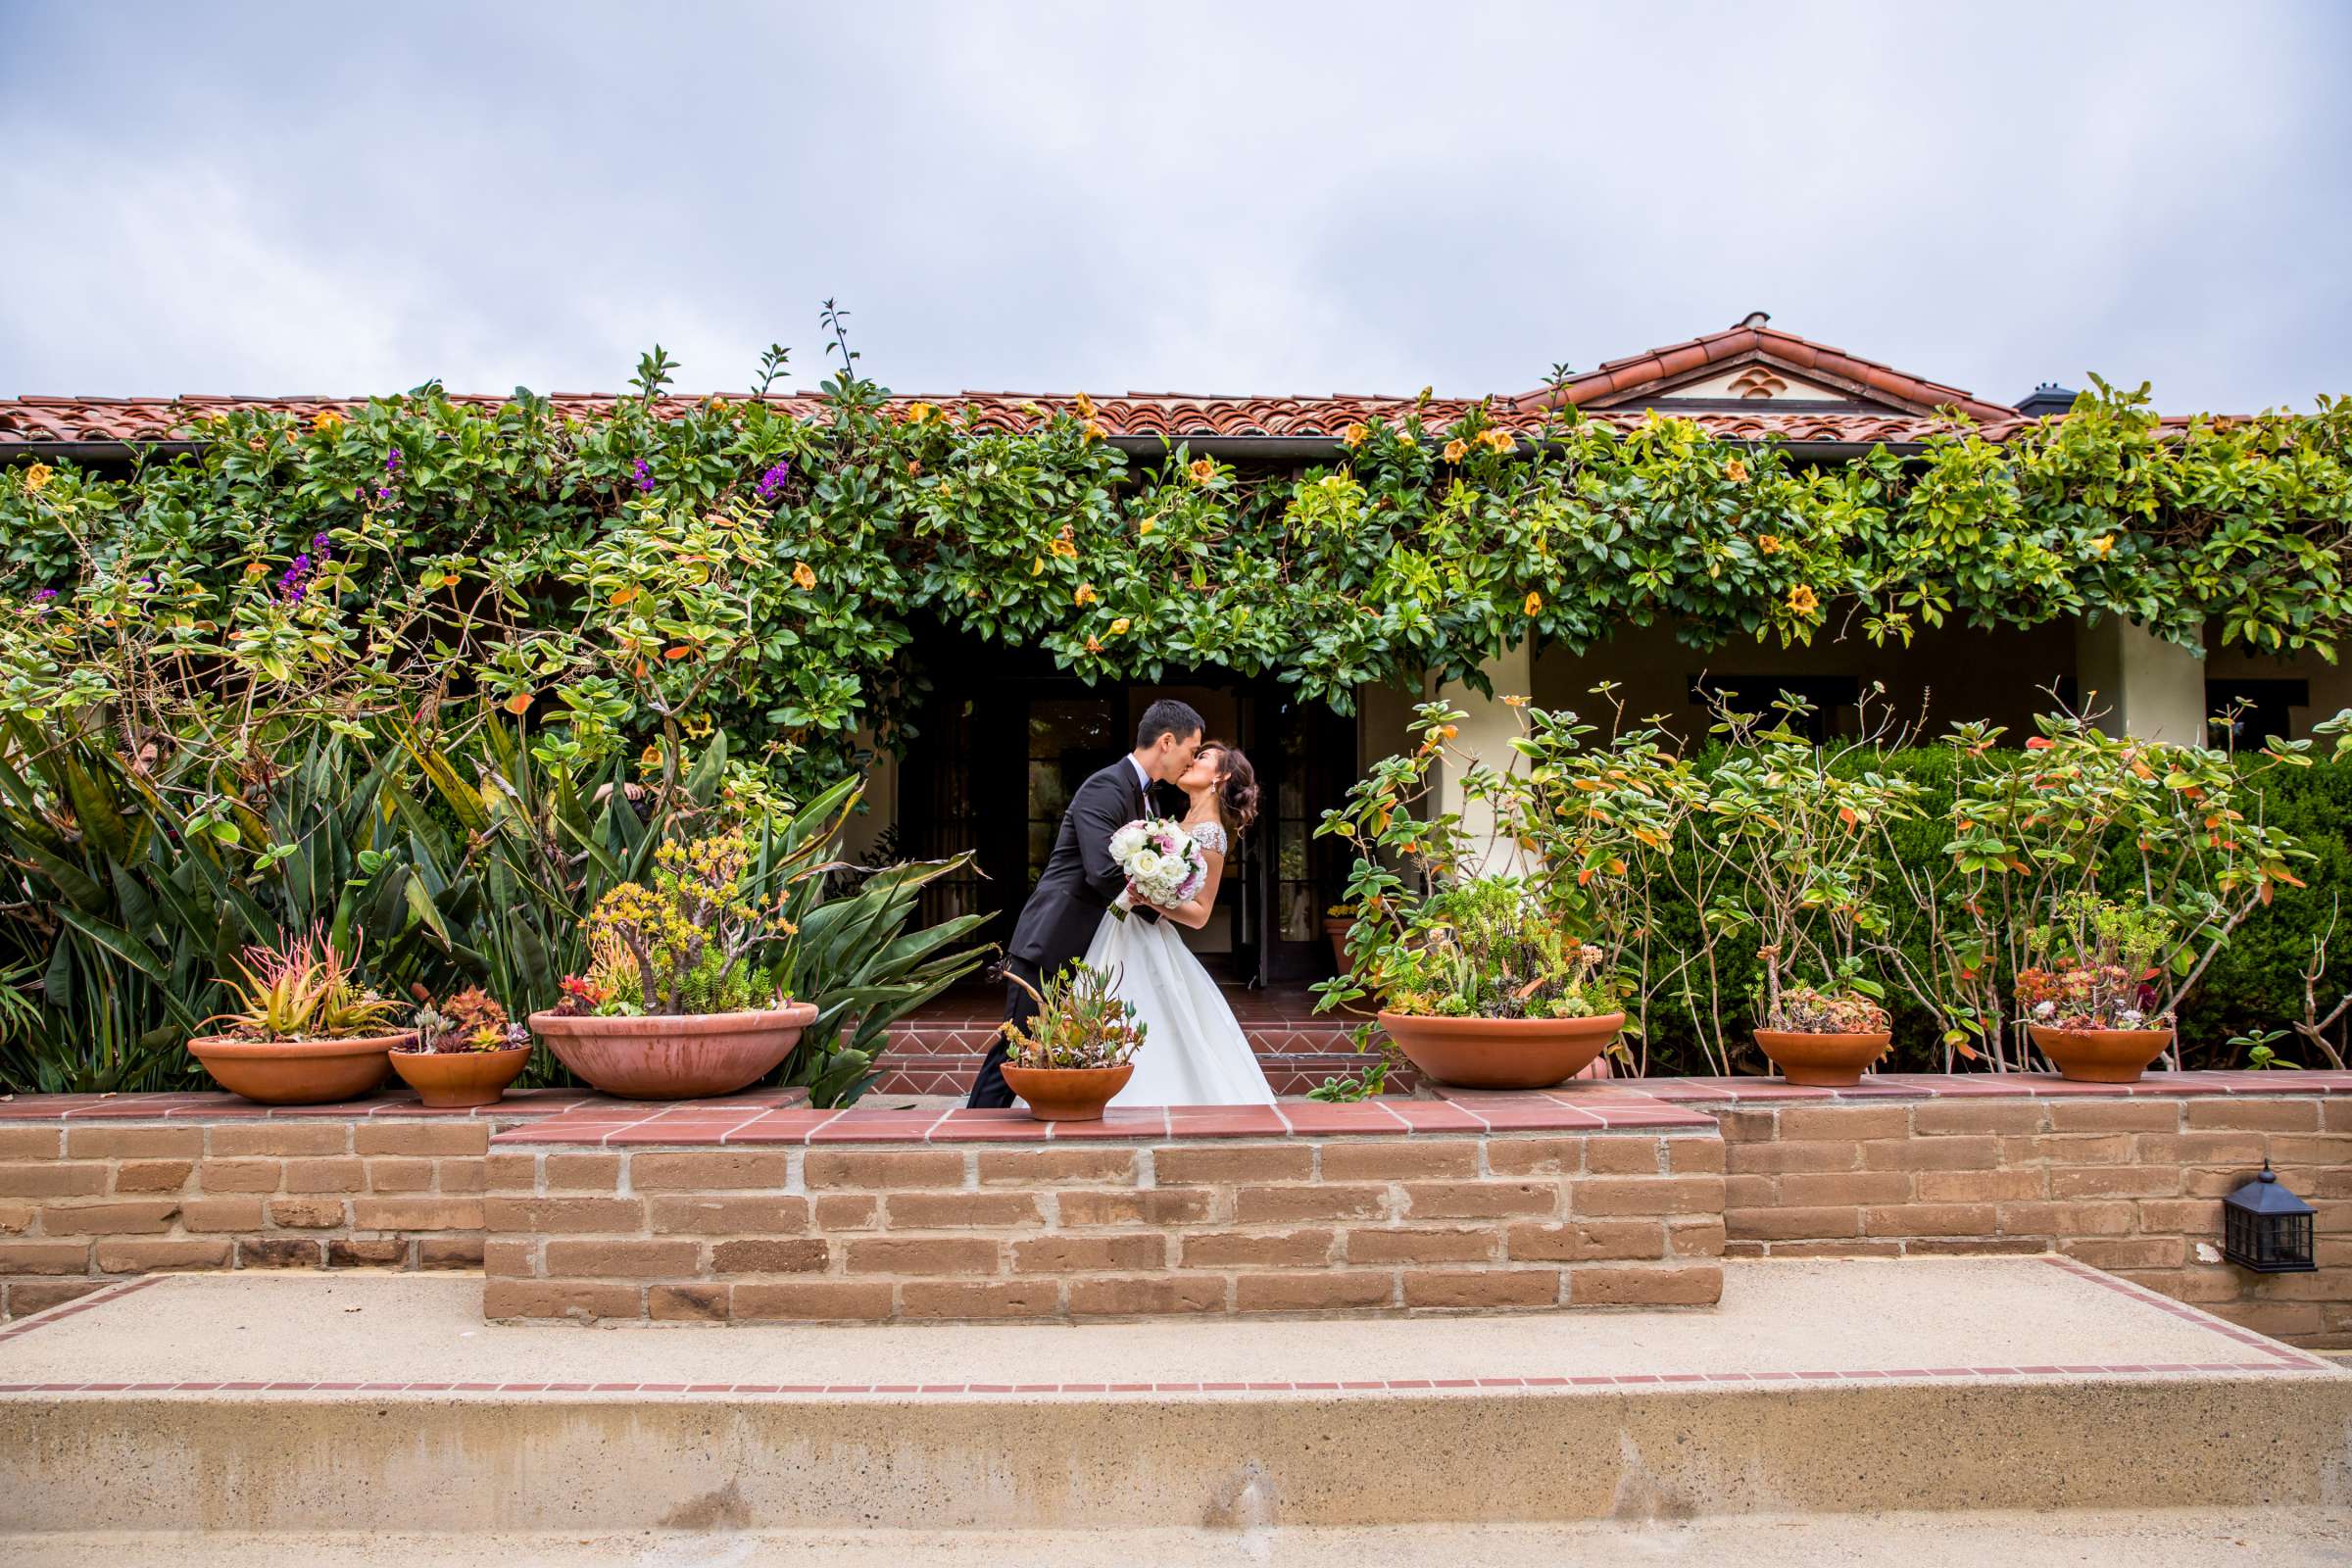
(0, 1257, 2352, 1533)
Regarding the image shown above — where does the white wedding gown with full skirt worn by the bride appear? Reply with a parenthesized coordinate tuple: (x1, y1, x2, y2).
(1087, 823, 1275, 1104)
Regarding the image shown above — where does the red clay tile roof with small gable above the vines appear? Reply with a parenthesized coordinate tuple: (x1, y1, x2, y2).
(0, 318, 2060, 449)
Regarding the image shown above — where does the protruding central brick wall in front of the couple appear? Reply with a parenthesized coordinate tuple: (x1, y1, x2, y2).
(484, 1131, 1724, 1321)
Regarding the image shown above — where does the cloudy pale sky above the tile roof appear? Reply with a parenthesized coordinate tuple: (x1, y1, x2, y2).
(0, 0, 2352, 412)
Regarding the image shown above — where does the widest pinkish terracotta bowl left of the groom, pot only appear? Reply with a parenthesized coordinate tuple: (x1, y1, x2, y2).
(531, 1002, 816, 1101)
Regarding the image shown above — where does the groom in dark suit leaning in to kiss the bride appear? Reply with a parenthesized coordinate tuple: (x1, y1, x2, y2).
(969, 698, 1201, 1109)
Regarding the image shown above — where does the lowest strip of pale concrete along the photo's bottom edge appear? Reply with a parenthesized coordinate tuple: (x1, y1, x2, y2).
(0, 1509, 2352, 1568)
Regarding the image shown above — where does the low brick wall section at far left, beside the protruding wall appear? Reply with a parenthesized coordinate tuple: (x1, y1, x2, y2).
(0, 1116, 492, 1319)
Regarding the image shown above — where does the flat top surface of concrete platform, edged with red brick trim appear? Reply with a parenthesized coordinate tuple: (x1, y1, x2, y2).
(0, 1257, 2347, 1394)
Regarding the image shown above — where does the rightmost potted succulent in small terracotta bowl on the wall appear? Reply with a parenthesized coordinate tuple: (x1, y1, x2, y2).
(2016, 894, 2174, 1084)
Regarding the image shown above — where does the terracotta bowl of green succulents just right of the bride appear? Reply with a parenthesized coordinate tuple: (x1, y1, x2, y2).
(1374, 877, 1625, 1089)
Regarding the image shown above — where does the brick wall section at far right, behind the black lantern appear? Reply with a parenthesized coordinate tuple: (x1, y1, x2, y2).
(1719, 1093, 2352, 1348)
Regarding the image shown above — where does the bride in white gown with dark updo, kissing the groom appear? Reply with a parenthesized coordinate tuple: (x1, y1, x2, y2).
(1087, 741, 1275, 1104)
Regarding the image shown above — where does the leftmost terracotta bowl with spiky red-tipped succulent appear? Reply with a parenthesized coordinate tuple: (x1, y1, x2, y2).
(188, 926, 416, 1104)
